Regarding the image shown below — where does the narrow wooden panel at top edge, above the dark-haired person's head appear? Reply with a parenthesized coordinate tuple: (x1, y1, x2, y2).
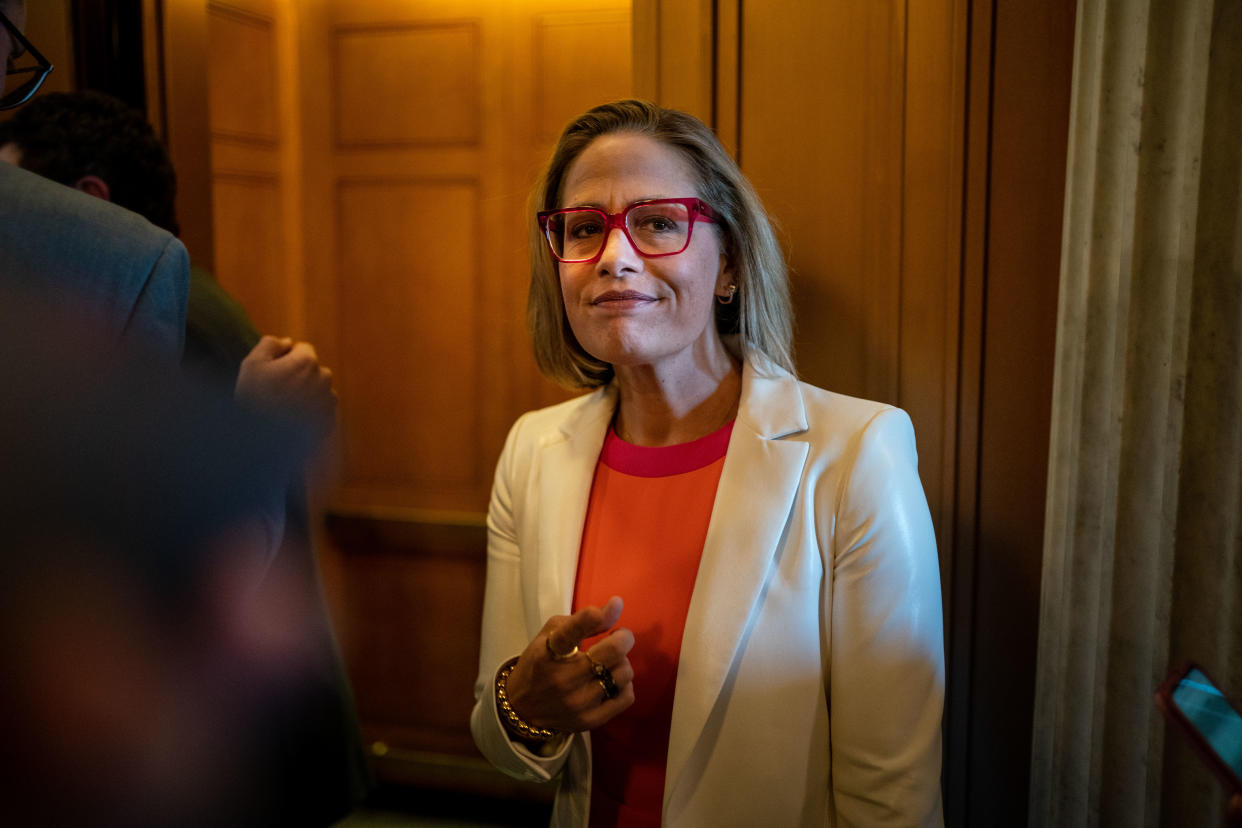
(207, 2, 279, 145)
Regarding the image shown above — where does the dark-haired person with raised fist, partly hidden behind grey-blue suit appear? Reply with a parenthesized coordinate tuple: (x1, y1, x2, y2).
(0, 92, 368, 826)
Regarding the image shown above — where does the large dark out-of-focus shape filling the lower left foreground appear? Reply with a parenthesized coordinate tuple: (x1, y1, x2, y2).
(0, 292, 315, 828)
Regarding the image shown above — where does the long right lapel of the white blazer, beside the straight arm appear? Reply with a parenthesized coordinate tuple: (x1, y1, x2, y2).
(664, 362, 809, 804)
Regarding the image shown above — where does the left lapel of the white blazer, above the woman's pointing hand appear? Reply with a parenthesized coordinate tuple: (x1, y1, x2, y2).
(535, 386, 616, 629)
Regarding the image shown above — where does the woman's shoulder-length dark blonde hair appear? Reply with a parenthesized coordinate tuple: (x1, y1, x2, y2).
(527, 101, 794, 389)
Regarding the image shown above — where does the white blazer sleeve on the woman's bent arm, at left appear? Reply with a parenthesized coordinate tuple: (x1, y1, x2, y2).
(469, 417, 573, 782)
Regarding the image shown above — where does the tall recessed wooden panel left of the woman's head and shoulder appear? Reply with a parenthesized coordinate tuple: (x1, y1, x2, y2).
(337, 180, 488, 506)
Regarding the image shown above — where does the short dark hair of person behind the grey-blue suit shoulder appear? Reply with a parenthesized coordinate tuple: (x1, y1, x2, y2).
(0, 92, 180, 236)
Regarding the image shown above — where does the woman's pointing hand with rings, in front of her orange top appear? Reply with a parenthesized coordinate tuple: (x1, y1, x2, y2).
(505, 596, 633, 732)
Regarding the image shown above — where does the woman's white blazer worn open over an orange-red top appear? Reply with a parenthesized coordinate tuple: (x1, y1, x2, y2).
(471, 364, 944, 828)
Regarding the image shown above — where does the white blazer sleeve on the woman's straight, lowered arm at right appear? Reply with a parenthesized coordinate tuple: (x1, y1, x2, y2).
(826, 408, 944, 826)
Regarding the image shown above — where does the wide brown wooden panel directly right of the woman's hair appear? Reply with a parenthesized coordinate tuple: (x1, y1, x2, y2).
(739, 0, 905, 402)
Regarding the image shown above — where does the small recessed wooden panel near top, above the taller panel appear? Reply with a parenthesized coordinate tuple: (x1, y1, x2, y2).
(333, 22, 482, 149)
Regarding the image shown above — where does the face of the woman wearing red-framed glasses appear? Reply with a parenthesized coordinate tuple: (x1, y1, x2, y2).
(558, 133, 732, 379)
